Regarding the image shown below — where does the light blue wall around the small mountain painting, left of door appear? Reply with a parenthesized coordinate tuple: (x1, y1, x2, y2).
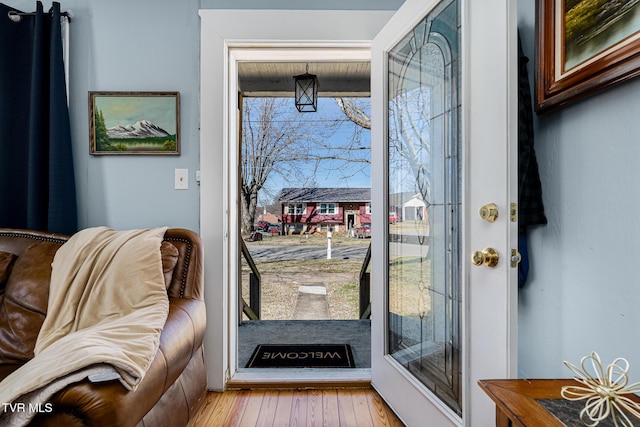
(5, 0, 402, 231)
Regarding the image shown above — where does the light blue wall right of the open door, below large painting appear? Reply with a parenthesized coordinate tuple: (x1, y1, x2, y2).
(518, 0, 640, 381)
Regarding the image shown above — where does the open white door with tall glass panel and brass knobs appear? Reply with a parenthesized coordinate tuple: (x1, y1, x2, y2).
(372, 0, 517, 426)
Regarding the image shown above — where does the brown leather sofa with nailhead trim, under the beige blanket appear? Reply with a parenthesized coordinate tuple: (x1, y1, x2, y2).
(0, 229, 206, 427)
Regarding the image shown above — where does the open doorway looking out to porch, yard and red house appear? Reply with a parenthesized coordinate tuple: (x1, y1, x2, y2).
(237, 61, 371, 378)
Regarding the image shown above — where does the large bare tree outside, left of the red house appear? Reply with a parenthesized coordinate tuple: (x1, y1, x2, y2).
(241, 98, 370, 233)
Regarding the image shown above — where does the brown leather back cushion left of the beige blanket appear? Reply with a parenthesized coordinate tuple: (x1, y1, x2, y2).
(0, 242, 60, 364)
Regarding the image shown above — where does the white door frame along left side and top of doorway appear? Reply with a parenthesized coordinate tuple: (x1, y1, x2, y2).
(199, 9, 393, 391)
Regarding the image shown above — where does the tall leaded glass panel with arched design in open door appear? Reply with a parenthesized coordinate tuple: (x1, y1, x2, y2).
(387, 0, 462, 414)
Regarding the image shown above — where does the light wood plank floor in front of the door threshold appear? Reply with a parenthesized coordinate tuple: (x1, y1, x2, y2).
(188, 388, 403, 427)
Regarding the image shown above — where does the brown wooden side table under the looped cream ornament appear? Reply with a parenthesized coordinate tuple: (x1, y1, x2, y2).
(478, 379, 640, 427)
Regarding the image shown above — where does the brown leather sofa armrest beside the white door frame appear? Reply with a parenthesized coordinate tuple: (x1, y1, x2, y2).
(28, 298, 206, 427)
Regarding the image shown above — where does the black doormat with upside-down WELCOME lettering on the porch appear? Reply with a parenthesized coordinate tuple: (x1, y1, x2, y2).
(246, 344, 356, 368)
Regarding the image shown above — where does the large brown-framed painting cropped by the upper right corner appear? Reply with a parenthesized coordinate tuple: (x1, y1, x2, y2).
(535, 0, 640, 113)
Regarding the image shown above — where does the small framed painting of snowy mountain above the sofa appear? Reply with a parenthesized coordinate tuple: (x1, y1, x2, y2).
(89, 92, 180, 155)
